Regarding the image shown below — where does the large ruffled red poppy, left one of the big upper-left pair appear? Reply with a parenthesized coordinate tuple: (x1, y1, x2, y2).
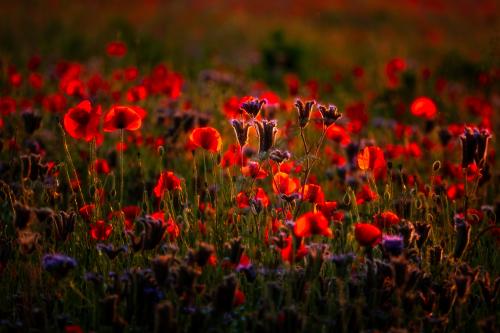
(63, 101, 101, 142)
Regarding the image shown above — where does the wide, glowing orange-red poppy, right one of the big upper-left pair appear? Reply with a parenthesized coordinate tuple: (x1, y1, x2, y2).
(104, 106, 143, 132)
